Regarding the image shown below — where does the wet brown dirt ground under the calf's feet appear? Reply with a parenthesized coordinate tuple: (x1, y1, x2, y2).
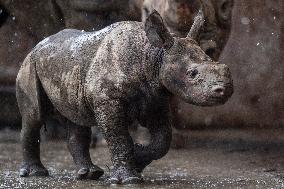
(0, 129, 284, 189)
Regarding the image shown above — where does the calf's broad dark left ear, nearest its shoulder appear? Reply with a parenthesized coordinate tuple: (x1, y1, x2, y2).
(144, 10, 174, 49)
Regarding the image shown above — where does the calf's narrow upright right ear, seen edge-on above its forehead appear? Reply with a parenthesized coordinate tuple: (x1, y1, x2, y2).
(187, 10, 205, 40)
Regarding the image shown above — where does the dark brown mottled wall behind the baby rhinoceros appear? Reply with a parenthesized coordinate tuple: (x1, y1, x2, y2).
(0, 0, 284, 128)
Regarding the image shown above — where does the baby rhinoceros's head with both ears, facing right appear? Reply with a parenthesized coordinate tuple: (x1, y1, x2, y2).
(145, 11, 233, 106)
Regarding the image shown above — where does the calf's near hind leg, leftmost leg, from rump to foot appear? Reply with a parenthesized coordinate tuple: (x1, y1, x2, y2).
(16, 56, 48, 177)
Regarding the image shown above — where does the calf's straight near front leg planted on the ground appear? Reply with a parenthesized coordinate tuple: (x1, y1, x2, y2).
(95, 100, 142, 184)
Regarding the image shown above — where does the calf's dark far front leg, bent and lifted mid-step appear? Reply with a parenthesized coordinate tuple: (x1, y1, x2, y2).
(134, 114, 172, 173)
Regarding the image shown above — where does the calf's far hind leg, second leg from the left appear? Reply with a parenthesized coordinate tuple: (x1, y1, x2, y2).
(67, 121, 104, 180)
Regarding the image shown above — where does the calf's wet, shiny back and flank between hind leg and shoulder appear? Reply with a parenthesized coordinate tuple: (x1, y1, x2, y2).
(33, 23, 122, 126)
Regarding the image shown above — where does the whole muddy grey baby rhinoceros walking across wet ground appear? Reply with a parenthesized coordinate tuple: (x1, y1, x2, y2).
(17, 11, 233, 184)
